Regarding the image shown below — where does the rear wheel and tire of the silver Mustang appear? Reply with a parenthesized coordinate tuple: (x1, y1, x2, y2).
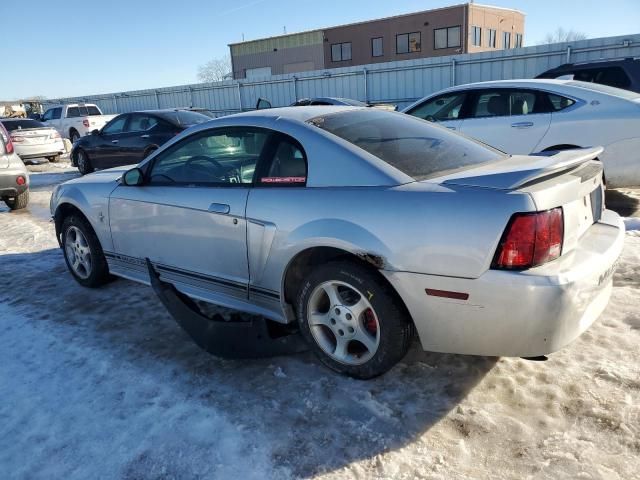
(296, 261, 414, 379)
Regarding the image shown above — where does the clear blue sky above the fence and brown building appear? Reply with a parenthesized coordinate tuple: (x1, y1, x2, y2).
(0, 0, 640, 100)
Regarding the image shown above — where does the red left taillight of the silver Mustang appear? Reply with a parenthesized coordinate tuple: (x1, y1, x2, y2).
(491, 208, 564, 270)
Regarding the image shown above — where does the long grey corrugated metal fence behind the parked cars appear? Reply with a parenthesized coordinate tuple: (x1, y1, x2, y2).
(46, 34, 640, 116)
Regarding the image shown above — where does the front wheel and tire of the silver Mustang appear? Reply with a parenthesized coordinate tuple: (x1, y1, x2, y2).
(62, 214, 109, 288)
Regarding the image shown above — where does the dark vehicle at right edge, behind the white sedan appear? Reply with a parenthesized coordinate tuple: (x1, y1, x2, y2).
(536, 58, 640, 92)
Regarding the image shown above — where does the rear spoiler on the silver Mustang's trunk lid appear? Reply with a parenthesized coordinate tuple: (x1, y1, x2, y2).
(438, 147, 604, 190)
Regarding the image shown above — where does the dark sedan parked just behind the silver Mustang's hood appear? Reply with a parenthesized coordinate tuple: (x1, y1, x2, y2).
(71, 109, 211, 175)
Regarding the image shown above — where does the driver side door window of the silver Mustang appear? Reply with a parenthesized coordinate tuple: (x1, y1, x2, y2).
(150, 128, 269, 186)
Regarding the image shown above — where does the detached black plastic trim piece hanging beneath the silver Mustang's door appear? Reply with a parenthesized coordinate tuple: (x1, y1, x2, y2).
(146, 258, 309, 358)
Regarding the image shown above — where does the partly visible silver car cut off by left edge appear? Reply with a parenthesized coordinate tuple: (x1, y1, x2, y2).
(0, 123, 29, 210)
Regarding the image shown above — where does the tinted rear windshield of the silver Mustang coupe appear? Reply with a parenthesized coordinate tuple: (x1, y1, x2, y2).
(310, 109, 506, 180)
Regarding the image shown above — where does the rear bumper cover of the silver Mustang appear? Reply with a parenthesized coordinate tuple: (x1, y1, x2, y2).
(383, 210, 624, 357)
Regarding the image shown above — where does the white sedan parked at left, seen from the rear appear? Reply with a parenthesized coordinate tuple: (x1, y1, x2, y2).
(0, 118, 64, 162)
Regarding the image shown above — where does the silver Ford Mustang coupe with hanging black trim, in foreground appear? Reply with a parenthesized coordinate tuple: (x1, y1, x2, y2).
(51, 106, 624, 378)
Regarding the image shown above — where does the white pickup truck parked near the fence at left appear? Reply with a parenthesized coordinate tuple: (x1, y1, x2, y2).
(42, 103, 115, 143)
